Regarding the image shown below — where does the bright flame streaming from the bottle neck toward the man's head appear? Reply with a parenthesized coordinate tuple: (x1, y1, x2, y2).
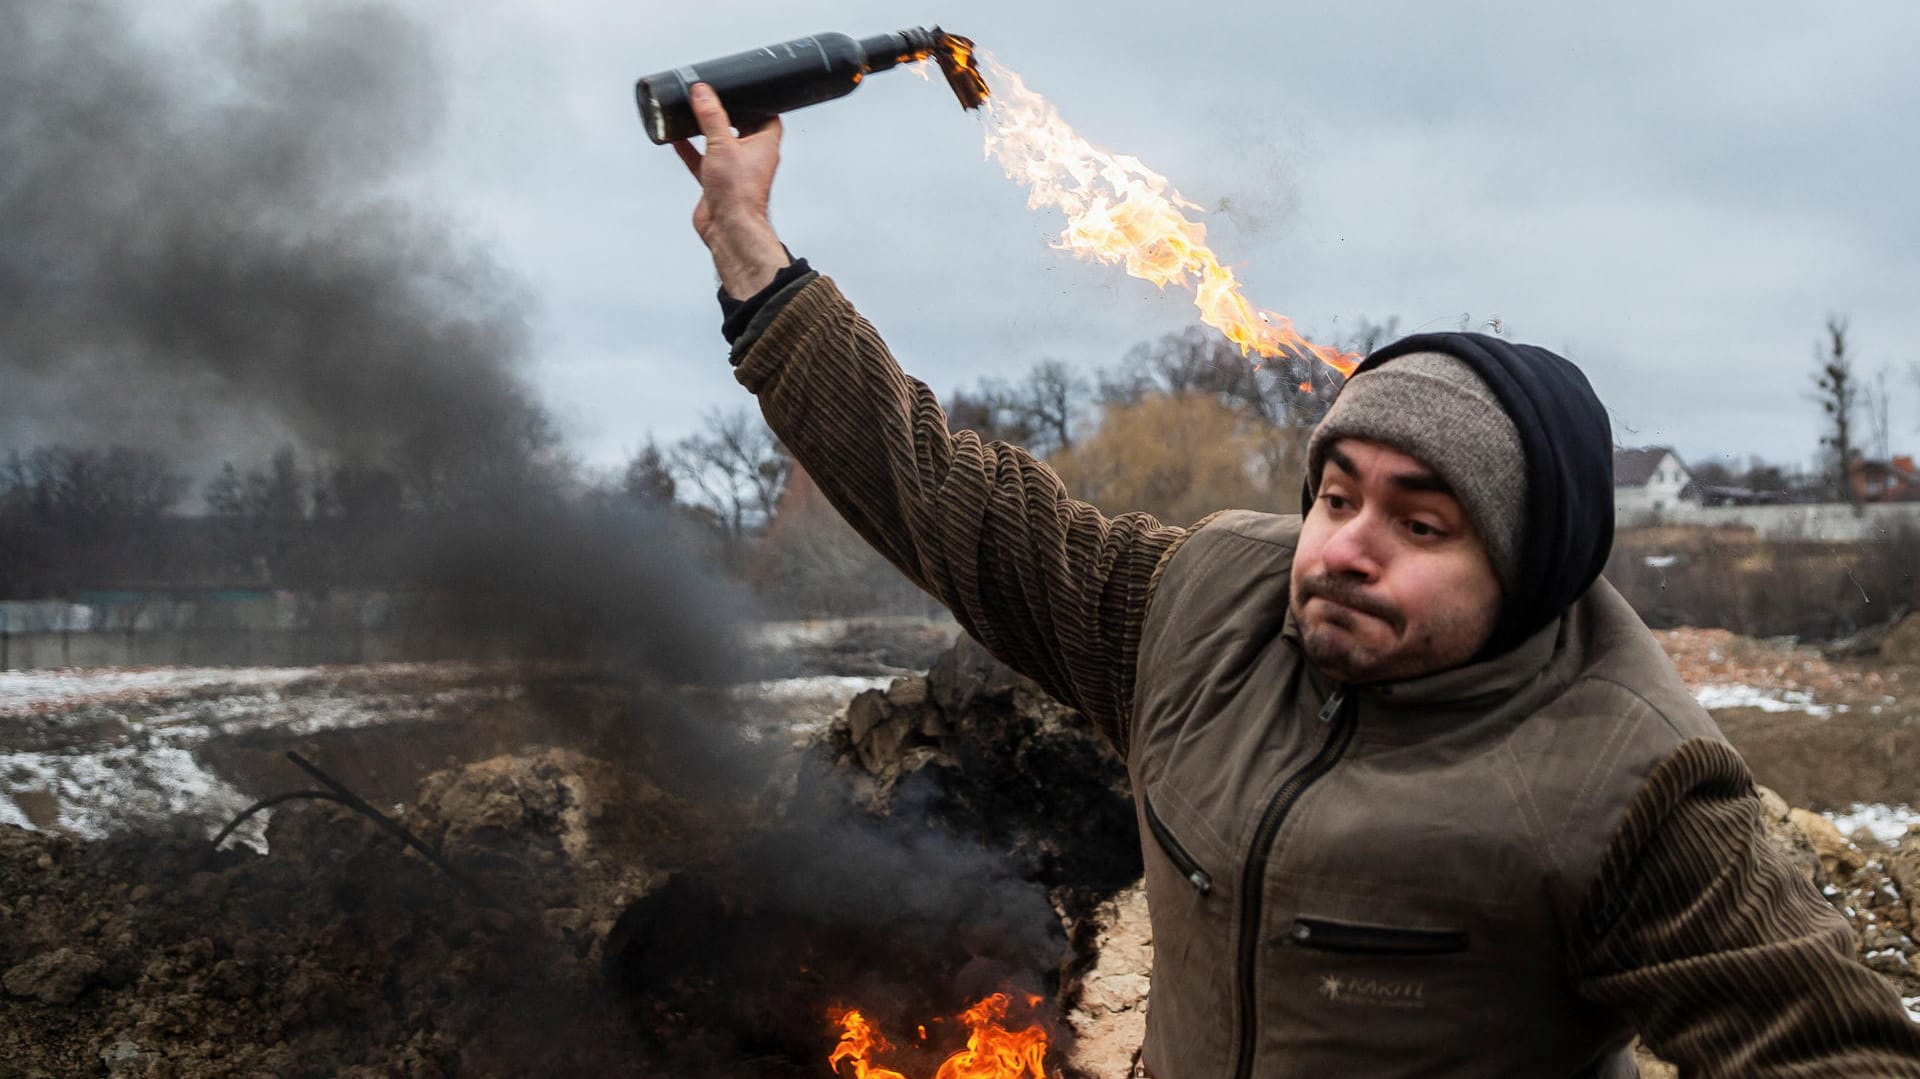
(979, 54, 1359, 374)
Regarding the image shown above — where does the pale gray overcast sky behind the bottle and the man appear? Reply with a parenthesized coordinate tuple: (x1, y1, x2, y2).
(176, 0, 1920, 463)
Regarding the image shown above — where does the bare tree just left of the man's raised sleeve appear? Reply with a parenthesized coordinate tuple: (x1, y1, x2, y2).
(672, 407, 793, 551)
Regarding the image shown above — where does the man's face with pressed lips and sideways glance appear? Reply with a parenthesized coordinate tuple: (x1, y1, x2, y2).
(1292, 438, 1500, 682)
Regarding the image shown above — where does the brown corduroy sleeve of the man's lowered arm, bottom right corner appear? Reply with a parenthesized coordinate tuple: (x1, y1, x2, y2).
(1572, 739, 1920, 1079)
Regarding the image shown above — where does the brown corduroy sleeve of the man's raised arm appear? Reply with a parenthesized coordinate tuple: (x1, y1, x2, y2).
(733, 276, 1188, 751)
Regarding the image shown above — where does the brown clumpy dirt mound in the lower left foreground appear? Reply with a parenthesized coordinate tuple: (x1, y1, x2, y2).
(0, 753, 698, 1077)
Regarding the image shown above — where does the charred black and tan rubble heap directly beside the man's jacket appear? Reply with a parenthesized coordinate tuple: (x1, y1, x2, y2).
(828, 637, 1152, 1079)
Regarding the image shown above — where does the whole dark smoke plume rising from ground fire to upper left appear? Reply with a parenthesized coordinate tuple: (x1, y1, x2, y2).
(0, 0, 1090, 1043)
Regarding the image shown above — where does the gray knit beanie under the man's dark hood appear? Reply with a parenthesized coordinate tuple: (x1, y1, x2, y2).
(1308, 351, 1526, 595)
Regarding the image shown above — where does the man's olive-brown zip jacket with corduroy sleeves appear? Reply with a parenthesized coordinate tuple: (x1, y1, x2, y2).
(733, 276, 1920, 1079)
